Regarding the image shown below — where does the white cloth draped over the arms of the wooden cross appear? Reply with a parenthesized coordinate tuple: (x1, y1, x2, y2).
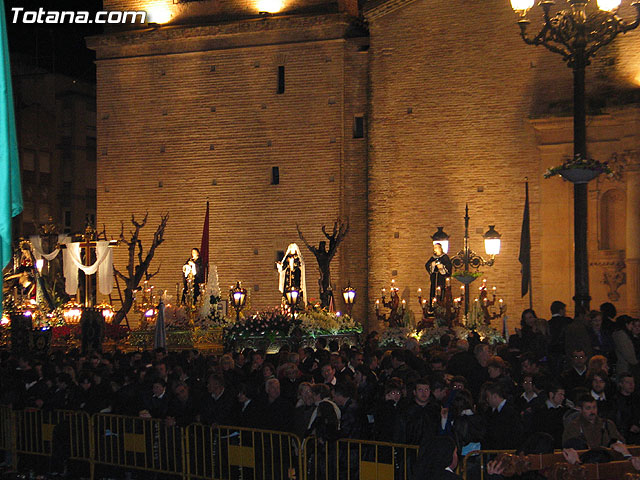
(63, 240, 113, 295)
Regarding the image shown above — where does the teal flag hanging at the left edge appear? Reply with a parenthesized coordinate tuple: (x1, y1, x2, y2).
(0, 0, 22, 313)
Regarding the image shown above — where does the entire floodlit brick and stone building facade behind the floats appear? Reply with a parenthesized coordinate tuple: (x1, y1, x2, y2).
(88, 0, 640, 327)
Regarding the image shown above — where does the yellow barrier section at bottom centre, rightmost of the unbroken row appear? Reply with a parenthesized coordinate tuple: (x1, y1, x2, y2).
(302, 437, 419, 480)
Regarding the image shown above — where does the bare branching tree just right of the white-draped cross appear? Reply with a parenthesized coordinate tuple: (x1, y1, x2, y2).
(113, 212, 169, 325)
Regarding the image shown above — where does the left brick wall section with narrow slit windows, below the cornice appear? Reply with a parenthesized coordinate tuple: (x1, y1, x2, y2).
(91, 15, 367, 318)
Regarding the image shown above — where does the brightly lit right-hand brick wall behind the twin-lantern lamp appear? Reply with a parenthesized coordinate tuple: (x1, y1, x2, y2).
(369, 0, 640, 328)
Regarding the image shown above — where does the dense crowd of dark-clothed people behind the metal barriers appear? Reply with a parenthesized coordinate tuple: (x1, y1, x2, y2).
(0, 302, 640, 478)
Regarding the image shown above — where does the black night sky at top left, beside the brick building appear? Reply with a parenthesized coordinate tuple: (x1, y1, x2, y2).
(4, 0, 103, 83)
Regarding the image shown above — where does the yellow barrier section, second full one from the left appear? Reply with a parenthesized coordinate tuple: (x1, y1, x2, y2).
(92, 414, 186, 478)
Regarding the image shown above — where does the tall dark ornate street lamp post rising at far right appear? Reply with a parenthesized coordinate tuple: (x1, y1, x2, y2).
(511, 0, 640, 311)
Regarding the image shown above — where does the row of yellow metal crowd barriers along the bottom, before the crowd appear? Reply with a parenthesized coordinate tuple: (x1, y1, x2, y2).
(7, 406, 640, 480)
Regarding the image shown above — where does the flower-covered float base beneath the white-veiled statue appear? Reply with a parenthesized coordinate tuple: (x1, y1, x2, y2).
(223, 306, 362, 353)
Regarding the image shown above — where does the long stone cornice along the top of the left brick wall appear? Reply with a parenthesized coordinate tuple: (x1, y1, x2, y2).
(87, 13, 357, 59)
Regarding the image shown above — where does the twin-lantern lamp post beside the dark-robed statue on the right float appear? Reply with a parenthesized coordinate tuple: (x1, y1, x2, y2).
(438, 205, 500, 315)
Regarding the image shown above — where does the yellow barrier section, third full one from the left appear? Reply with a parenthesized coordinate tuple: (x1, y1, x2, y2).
(186, 424, 302, 480)
